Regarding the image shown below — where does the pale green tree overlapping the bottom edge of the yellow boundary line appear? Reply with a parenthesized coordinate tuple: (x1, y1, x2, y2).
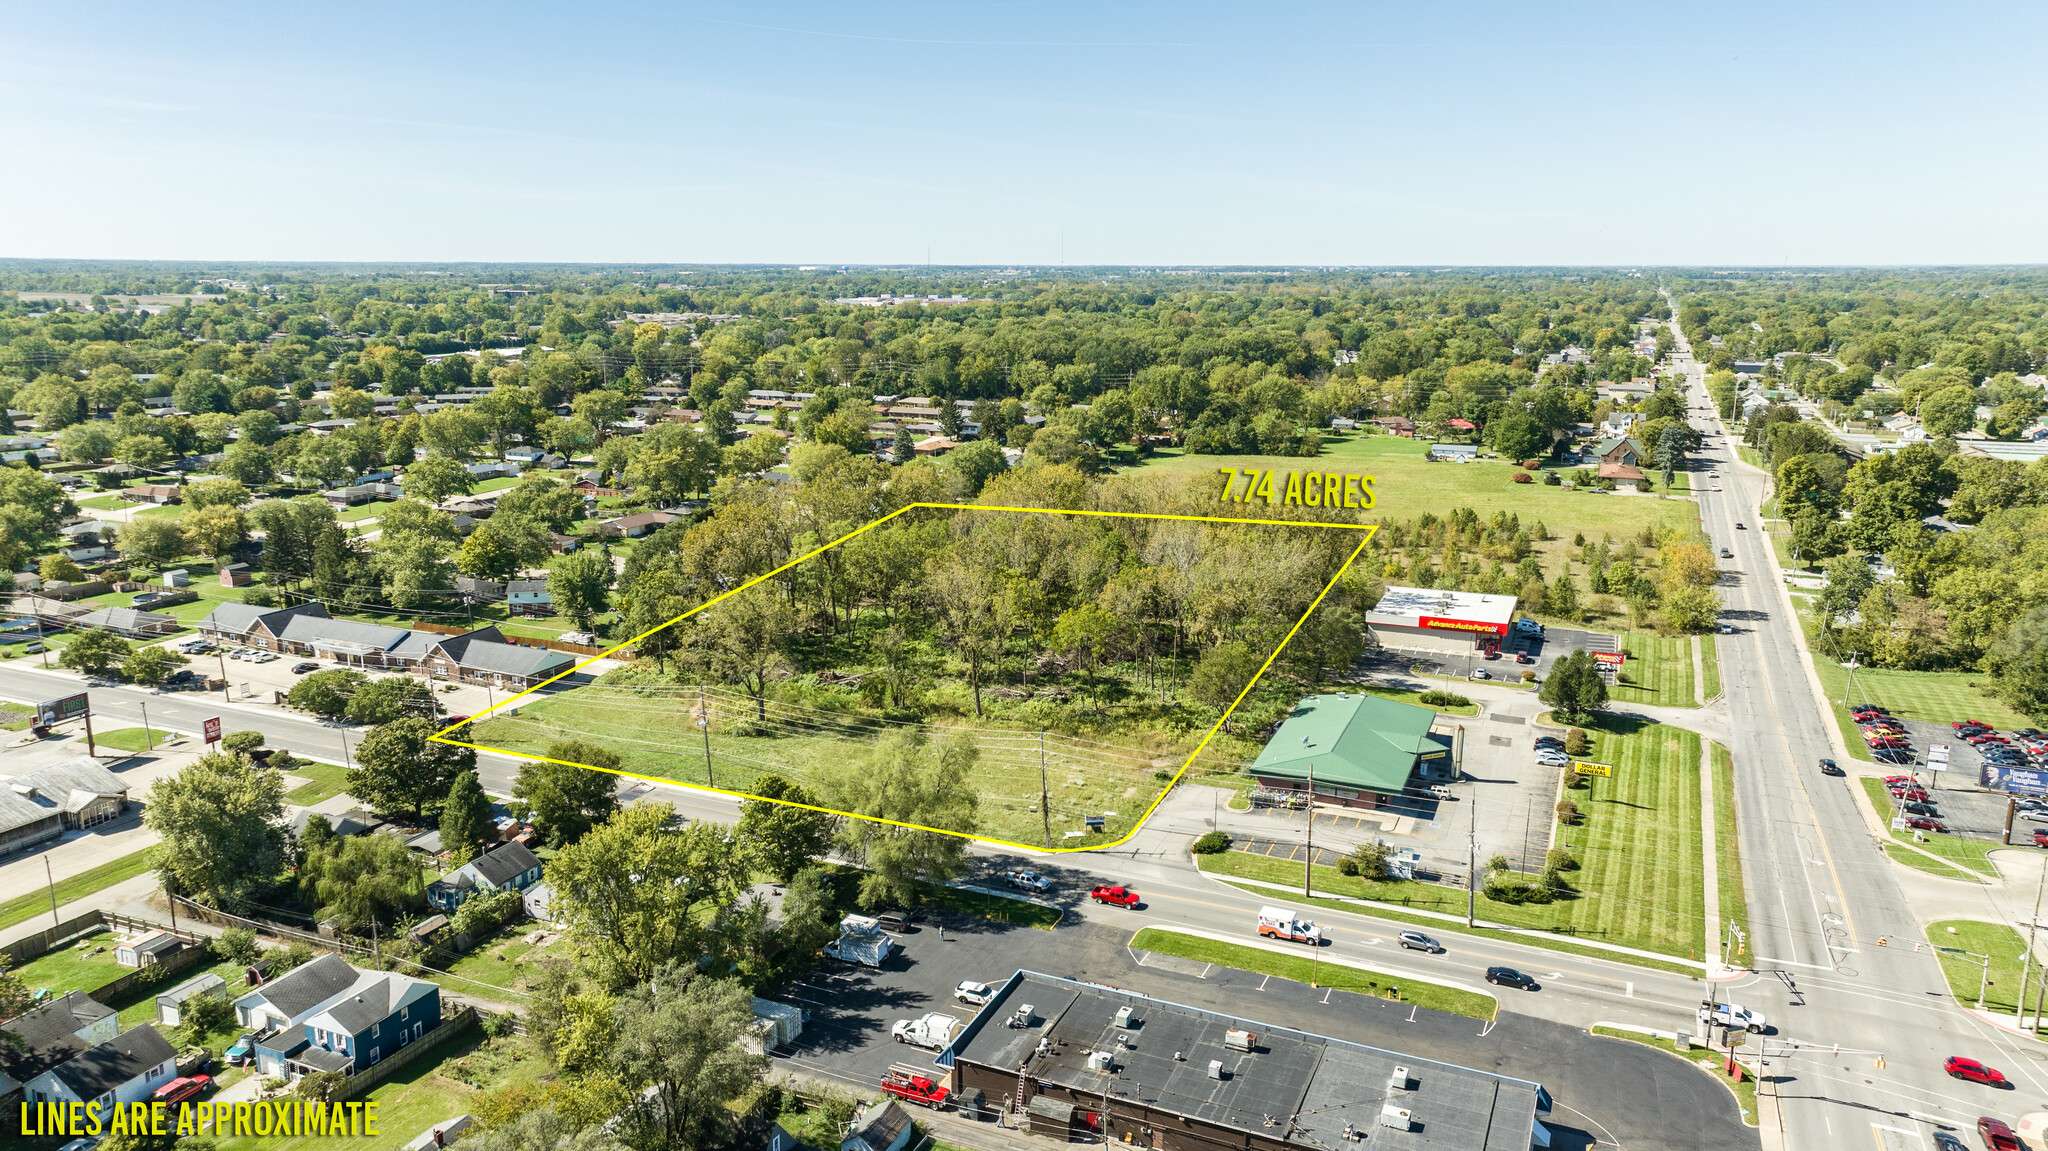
(831, 729, 981, 907)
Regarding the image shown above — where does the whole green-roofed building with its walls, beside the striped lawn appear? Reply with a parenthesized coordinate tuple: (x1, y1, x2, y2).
(1249, 694, 1458, 807)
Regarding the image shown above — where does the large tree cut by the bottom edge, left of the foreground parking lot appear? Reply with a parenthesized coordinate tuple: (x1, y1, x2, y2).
(606, 973, 768, 1147)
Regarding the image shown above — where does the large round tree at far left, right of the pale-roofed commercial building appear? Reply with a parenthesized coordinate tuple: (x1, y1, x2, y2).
(141, 752, 285, 907)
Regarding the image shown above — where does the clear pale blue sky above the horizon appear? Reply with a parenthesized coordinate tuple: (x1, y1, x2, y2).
(0, 0, 2048, 266)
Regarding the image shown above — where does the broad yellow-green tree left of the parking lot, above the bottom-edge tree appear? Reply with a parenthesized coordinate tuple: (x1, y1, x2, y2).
(547, 803, 752, 987)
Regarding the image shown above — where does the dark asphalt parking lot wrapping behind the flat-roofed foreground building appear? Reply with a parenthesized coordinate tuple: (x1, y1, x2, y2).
(774, 901, 1757, 1149)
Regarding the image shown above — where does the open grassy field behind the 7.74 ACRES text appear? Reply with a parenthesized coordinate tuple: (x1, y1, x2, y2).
(1120, 436, 1698, 541)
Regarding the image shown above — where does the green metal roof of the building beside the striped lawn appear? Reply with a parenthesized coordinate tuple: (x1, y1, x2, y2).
(1251, 694, 1442, 793)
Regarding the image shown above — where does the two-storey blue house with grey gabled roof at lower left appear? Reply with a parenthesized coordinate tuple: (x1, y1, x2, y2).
(236, 954, 440, 1075)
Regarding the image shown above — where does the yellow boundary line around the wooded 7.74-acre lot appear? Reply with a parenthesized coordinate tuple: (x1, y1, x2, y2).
(430, 504, 1378, 854)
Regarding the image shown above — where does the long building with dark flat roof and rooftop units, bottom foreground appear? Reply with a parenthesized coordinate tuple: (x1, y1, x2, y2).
(938, 971, 1550, 1151)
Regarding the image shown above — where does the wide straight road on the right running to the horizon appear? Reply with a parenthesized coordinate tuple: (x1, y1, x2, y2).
(1671, 296, 2048, 1149)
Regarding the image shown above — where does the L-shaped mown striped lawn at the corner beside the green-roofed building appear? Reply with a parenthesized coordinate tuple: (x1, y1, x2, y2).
(1198, 719, 1735, 961)
